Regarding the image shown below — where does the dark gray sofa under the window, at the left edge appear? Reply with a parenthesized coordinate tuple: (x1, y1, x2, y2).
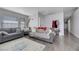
(0, 28, 24, 43)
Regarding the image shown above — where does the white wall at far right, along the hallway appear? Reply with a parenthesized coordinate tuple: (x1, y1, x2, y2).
(70, 8, 79, 38)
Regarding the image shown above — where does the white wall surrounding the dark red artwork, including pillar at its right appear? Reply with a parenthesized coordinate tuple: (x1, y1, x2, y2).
(41, 12, 64, 36)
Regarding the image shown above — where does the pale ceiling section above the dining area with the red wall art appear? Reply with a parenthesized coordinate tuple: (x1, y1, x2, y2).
(38, 7, 62, 15)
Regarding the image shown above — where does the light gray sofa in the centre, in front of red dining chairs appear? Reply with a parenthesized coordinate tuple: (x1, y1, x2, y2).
(29, 32, 56, 43)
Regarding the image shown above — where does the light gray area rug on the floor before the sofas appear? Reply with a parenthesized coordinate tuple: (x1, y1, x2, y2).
(0, 37, 45, 51)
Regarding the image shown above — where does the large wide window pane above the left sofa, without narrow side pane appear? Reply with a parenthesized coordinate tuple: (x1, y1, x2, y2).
(2, 16, 18, 28)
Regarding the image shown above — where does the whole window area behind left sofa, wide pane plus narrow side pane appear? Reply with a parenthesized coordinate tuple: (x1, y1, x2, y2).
(0, 16, 25, 30)
